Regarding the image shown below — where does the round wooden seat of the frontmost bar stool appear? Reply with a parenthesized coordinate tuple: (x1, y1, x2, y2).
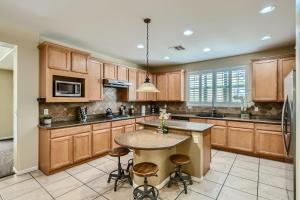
(133, 162, 158, 177)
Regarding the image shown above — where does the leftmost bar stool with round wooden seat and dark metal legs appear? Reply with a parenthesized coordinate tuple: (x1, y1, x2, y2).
(107, 147, 132, 191)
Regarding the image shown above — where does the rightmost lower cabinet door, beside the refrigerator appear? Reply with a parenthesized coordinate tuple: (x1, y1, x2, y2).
(256, 130, 284, 156)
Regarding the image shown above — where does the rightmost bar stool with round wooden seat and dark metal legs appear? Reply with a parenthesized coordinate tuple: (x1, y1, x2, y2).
(167, 154, 193, 194)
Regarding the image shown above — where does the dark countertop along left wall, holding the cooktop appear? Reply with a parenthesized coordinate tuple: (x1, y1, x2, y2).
(39, 114, 157, 129)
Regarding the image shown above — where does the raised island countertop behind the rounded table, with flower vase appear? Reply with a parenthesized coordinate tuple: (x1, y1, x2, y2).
(137, 120, 214, 132)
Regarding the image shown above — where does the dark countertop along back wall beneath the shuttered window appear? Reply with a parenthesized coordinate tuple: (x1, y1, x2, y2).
(171, 114, 281, 124)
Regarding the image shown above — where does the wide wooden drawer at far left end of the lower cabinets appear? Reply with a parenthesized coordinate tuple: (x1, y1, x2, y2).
(51, 125, 92, 138)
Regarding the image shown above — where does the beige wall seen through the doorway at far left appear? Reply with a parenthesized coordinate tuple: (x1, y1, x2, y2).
(0, 67, 13, 139)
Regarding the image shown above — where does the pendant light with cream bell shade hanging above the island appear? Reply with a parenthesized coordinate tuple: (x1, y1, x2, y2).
(136, 18, 159, 92)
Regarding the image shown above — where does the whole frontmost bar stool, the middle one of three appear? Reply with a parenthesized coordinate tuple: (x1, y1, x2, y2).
(133, 162, 159, 200)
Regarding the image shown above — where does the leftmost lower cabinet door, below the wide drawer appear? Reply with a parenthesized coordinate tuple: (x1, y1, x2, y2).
(50, 136, 73, 170)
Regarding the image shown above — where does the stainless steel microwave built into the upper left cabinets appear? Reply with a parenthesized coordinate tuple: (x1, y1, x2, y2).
(54, 80, 81, 97)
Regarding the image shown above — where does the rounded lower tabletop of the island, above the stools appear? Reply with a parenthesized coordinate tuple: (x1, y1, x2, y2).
(115, 130, 191, 150)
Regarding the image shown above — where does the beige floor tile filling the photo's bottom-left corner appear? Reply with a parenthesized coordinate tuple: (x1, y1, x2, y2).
(0, 179, 41, 200)
